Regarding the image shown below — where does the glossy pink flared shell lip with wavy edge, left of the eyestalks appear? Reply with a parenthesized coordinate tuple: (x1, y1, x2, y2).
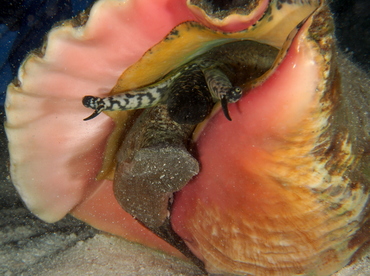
(6, 0, 267, 256)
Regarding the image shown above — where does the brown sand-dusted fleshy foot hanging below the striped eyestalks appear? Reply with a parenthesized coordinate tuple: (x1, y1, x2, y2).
(114, 105, 203, 268)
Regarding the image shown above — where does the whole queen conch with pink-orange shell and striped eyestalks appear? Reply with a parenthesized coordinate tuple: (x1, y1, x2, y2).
(5, 0, 370, 276)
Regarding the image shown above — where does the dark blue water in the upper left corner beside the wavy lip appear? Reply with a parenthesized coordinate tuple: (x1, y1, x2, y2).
(0, 0, 93, 104)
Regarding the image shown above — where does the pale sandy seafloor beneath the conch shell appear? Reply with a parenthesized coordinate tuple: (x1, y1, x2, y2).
(0, 110, 370, 276)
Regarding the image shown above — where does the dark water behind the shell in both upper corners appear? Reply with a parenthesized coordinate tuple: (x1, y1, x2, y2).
(0, 0, 370, 105)
